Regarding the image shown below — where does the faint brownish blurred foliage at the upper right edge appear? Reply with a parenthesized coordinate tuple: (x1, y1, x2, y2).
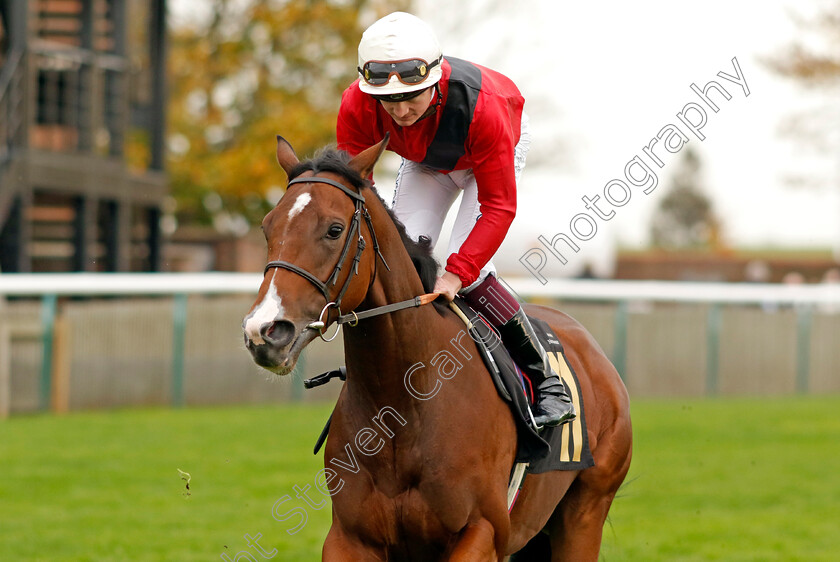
(763, 0, 840, 185)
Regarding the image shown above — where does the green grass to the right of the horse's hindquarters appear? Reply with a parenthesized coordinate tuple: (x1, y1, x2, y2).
(602, 397, 840, 562)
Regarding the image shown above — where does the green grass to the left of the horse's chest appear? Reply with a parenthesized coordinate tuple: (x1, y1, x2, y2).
(0, 406, 330, 562)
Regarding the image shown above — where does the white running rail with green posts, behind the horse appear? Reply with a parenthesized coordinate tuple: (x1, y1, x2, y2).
(0, 273, 840, 418)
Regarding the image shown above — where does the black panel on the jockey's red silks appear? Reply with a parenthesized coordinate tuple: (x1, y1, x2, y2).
(421, 57, 481, 170)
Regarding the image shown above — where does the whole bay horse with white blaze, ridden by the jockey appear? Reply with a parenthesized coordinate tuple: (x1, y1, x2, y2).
(243, 136, 632, 562)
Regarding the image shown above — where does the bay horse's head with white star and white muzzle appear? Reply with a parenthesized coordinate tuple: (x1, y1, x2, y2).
(242, 136, 388, 375)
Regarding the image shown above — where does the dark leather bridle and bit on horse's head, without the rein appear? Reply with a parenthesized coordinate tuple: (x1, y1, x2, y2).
(263, 176, 391, 341)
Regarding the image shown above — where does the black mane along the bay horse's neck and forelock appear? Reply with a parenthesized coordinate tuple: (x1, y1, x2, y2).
(289, 148, 438, 293)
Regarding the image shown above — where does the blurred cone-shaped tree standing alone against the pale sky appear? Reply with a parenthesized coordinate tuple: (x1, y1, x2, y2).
(650, 147, 721, 249)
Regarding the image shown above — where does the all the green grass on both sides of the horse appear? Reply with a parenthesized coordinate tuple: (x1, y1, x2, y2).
(0, 397, 840, 562)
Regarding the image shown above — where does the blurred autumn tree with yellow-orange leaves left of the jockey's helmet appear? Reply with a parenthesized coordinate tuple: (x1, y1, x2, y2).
(168, 0, 408, 234)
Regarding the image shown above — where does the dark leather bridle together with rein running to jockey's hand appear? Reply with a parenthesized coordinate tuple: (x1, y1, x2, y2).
(263, 176, 438, 341)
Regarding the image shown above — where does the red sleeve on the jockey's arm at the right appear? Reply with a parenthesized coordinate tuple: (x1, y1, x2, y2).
(446, 97, 521, 287)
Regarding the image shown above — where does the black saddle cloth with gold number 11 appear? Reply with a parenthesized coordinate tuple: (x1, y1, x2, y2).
(454, 298, 595, 474)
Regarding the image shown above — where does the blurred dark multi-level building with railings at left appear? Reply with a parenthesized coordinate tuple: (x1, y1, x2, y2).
(0, 0, 167, 272)
